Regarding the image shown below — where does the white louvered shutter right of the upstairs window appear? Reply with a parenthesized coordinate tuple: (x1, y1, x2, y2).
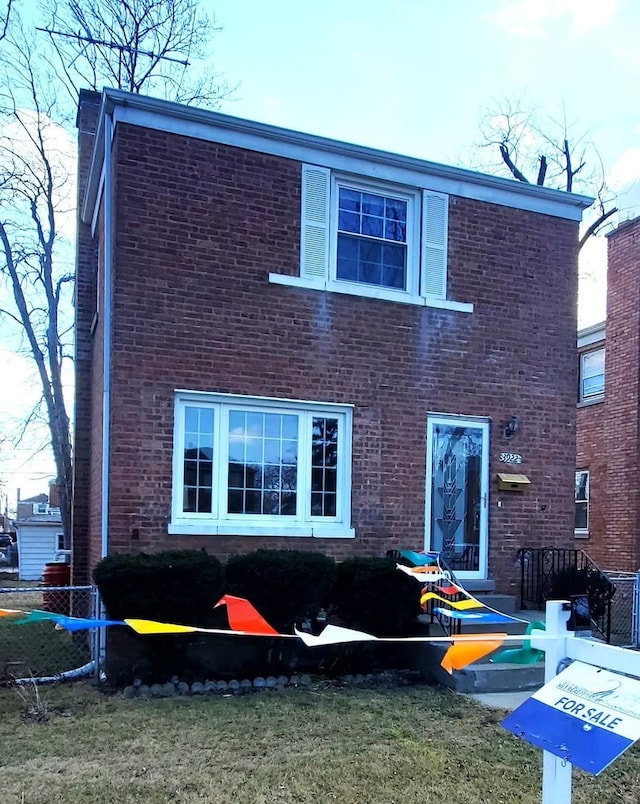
(422, 190, 449, 299)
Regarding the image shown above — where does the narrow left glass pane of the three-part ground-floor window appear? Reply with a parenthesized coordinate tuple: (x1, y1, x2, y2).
(182, 405, 213, 513)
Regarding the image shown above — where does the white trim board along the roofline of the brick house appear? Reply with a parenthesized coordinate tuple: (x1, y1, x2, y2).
(82, 89, 593, 222)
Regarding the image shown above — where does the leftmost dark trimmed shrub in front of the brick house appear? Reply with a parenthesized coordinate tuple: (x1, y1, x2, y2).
(93, 550, 224, 627)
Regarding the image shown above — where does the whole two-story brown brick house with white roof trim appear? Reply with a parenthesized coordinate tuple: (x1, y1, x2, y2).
(73, 90, 590, 591)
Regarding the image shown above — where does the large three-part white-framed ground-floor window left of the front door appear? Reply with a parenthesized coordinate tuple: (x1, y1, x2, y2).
(170, 392, 353, 536)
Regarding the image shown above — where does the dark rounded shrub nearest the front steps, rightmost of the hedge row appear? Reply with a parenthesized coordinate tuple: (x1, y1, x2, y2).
(333, 558, 420, 636)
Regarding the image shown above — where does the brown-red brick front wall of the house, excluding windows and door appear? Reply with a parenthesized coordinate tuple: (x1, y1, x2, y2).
(74, 116, 577, 591)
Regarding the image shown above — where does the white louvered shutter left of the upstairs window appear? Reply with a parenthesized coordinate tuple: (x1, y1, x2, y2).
(300, 165, 330, 280)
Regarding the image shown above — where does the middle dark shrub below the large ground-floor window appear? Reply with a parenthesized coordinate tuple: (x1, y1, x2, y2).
(225, 550, 335, 633)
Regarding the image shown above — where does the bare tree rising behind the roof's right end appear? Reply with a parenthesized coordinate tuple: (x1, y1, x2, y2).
(479, 100, 618, 249)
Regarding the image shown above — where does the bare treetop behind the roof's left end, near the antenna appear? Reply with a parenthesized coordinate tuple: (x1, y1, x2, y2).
(43, 0, 229, 106)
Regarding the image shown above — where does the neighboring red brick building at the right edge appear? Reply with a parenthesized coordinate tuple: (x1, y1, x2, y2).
(575, 218, 640, 572)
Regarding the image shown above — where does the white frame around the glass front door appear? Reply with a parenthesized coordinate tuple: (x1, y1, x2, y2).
(424, 413, 490, 579)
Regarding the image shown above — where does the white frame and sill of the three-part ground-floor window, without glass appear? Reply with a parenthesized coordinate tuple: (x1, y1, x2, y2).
(168, 390, 355, 538)
